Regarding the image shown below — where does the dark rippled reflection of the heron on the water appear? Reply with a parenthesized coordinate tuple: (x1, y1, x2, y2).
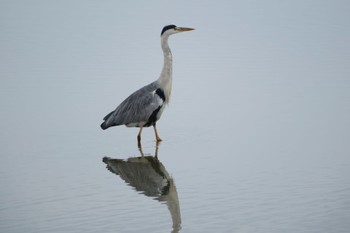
(103, 143, 181, 232)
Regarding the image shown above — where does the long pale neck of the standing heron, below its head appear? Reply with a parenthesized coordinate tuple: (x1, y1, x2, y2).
(158, 36, 173, 103)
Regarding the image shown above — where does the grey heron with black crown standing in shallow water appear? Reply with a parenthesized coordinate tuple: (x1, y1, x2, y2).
(101, 25, 194, 143)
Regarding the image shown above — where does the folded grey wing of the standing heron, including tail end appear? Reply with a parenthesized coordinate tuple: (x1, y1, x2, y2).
(103, 82, 164, 128)
